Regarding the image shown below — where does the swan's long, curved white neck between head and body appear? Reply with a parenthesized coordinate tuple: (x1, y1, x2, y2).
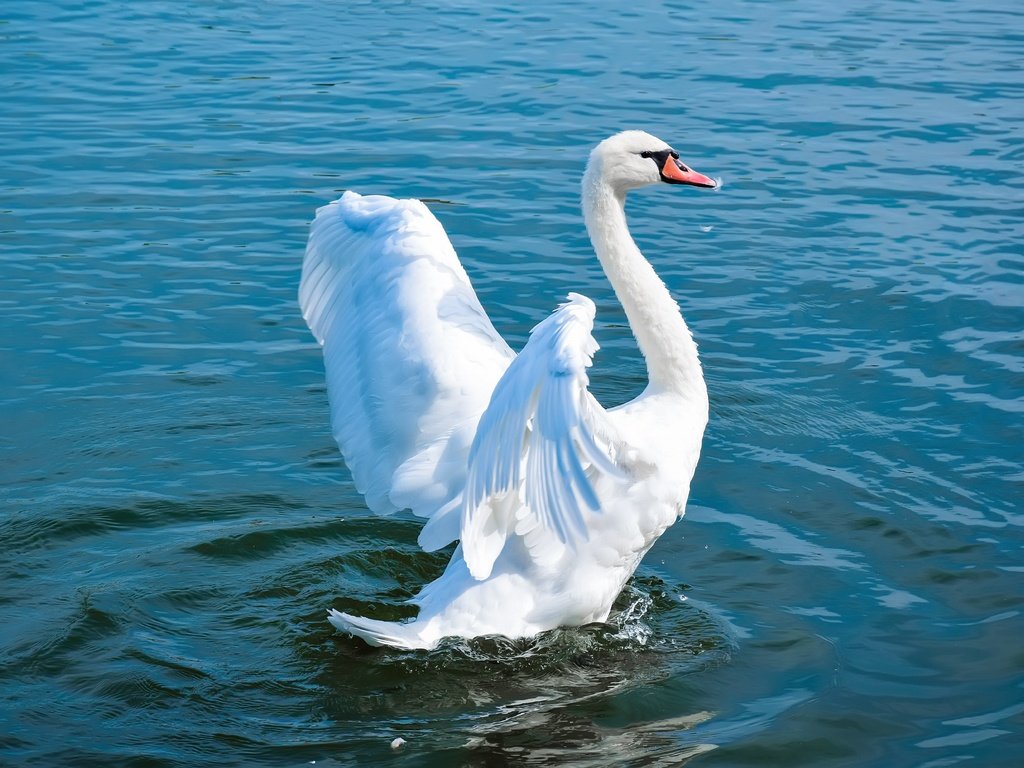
(583, 174, 707, 396)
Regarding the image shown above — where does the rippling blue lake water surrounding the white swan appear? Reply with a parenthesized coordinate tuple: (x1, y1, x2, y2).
(0, 0, 1024, 767)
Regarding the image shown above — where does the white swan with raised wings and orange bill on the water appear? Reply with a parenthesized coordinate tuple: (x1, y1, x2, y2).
(299, 130, 718, 649)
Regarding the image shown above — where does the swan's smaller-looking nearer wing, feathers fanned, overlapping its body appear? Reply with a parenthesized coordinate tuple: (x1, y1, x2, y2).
(461, 294, 625, 579)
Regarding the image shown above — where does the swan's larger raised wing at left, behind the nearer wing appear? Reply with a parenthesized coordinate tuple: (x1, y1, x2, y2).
(299, 191, 514, 549)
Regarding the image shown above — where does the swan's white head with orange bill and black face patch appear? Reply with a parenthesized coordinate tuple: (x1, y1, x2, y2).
(587, 131, 718, 194)
